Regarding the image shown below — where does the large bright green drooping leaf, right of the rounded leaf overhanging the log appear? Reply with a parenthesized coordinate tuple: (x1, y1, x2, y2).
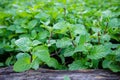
(32, 45, 50, 63)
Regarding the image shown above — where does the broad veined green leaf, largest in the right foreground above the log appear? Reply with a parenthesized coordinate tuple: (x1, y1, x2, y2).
(87, 45, 111, 59)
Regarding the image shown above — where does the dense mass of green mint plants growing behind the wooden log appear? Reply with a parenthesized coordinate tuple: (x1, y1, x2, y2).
(0, 0, 120, 72)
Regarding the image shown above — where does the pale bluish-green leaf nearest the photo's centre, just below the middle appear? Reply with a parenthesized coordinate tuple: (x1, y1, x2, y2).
(56, 37, 72, 48)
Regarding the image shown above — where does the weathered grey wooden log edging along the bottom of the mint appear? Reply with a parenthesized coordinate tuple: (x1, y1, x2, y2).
(0, 67, 120, 80)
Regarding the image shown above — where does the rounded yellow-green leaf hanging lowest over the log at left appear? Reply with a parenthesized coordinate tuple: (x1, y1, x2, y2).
(13, 53, 31, 72)
